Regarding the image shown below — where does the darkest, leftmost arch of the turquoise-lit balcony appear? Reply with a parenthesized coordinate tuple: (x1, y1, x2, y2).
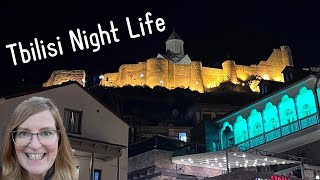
(220, 122, 234, 149)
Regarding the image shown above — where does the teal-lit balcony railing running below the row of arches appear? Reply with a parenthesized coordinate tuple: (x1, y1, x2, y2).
(236, 114, 319, 151)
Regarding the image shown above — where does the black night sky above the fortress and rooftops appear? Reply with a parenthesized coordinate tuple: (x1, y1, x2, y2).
(0, 0, 320, 96)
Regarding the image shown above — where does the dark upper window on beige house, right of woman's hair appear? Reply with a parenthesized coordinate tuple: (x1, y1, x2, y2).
(64, 109, 82, 134)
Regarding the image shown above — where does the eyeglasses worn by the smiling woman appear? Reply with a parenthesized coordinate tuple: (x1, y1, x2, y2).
(11, 130, 59, 146)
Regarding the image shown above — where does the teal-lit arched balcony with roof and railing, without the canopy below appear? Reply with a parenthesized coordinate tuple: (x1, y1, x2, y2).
(216, 75, 320, 150)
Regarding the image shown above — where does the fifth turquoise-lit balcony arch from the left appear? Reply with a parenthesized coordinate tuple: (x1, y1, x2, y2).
(278, 95, 297, 126)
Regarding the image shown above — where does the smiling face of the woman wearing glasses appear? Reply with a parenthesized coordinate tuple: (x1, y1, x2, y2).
(14, 110, 59, 177)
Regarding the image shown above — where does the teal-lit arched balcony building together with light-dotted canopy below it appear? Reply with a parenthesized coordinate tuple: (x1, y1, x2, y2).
(172, 75, 320, 174)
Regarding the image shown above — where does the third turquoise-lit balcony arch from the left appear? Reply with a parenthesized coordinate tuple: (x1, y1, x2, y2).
(248, 109, 263, 138)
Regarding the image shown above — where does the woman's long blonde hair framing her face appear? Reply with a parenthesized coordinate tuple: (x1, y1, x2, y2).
(0, 97, 77, 180)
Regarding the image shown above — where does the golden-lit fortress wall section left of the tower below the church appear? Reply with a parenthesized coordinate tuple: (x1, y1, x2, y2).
(119, 63, 146, 86)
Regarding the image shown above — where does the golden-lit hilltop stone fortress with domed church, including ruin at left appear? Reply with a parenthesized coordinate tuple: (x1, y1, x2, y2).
(44, 32, 293, 93)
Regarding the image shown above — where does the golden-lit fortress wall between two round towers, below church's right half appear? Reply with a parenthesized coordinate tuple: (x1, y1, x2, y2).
(174, 64, 191, 88)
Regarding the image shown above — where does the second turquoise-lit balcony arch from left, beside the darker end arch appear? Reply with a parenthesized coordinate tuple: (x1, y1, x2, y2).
(234, 116, 248, 144)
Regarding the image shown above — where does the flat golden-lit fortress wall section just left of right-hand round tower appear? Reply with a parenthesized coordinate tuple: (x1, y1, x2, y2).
(202, 67, 224, 88)
